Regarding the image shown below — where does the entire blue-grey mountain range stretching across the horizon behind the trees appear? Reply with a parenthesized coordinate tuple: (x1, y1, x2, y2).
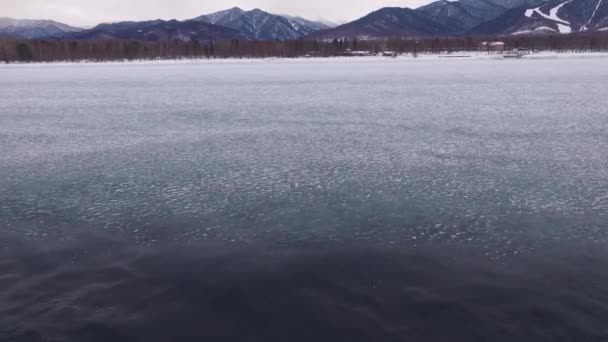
(0, 0, 608, 41)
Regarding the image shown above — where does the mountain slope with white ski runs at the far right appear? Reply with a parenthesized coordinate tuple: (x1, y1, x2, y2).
(473, 0, 608, 34)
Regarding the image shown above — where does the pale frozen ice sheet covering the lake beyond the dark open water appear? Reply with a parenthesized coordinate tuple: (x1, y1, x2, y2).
(0, 58, 608, 254)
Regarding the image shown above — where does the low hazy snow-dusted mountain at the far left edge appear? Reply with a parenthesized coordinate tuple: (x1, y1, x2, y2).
(0, 18, 82, 38)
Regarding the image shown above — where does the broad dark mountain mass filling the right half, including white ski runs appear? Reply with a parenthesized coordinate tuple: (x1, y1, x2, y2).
(311, 0, 608, 39)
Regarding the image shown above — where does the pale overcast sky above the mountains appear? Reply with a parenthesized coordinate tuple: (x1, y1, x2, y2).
(0, 0, 431, 26)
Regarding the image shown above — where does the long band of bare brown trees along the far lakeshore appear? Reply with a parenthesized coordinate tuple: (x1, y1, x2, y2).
(0, 32, 608, 63)
